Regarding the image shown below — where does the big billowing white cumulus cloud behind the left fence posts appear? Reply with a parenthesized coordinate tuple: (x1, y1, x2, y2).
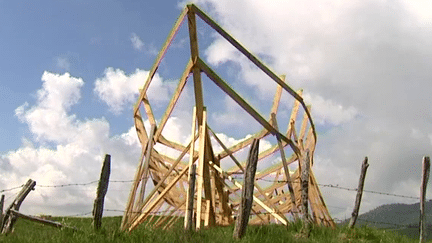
(0, 72, 141, 215)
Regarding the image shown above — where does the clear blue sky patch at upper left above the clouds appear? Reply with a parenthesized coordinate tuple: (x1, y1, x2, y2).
(0, 1, 184, 152)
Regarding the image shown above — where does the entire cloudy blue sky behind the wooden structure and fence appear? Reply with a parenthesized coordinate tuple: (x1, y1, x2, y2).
(0, 0, 432, 219)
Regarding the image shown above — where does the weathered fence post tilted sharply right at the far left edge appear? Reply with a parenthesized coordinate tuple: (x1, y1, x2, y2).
(1, 179, 36, 234)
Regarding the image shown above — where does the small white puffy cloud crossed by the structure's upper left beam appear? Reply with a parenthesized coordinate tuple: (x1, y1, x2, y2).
(94, 67, 173, 114)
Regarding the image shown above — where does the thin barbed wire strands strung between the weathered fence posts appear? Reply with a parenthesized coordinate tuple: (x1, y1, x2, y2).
(0, 177, 426, 229)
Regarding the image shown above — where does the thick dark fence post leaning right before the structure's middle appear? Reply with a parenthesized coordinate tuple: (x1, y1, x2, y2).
(233, 139, 259, 239)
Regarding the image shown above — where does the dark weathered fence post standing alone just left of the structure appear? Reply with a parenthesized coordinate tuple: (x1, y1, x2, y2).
(92, 154, 111, 230)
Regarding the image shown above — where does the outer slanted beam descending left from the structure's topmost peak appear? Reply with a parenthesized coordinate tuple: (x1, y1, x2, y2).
(134, 8, 188, 114)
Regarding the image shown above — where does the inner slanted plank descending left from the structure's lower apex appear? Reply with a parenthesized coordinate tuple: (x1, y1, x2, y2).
(154, 60, 192, 141)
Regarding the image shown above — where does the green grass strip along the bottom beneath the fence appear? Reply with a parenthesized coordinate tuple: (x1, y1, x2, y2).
(0, 217, 418, 243)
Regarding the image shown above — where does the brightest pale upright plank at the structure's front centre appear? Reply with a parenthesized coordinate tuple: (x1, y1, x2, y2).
(195, 107, 207, 230)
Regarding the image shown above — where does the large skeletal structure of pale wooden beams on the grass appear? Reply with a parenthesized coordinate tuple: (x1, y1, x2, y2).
(121, 4, 334, 231)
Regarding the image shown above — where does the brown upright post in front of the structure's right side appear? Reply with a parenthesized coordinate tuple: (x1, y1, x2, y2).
(301, 149, 310, 224)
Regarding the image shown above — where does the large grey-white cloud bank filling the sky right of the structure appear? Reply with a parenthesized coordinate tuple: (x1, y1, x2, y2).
(196, 0, 432, 218)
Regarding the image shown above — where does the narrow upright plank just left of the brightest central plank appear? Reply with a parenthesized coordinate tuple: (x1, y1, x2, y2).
(184, 107, 196, 230)
